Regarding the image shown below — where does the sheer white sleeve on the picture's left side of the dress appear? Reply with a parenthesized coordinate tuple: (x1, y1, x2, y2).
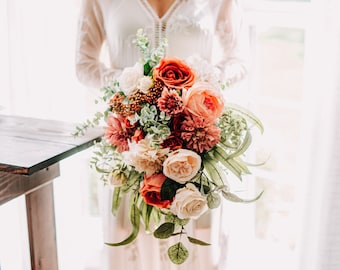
(76, 0, 119, 87)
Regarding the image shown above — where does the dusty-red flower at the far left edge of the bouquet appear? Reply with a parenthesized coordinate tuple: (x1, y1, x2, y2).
(105, 114, 130, 152)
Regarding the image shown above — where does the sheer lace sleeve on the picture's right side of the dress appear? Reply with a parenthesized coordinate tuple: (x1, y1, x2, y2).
(216, 0, 247, 84)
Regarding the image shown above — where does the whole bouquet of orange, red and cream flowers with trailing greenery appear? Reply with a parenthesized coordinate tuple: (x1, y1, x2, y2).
(74, 30, 263, 264)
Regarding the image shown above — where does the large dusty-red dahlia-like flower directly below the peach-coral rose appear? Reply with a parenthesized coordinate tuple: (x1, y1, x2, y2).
(180, 114, 221, 153)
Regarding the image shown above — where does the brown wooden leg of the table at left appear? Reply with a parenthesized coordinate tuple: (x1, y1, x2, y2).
(26, 181, 58, 270)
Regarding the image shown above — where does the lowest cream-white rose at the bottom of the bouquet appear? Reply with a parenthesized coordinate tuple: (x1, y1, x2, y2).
(170, 183, 208, 219)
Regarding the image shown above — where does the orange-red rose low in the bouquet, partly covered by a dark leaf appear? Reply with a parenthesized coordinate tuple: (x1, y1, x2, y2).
(140, 173, 171, 208)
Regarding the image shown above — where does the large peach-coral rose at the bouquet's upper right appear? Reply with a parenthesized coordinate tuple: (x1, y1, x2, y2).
(182, 82, 224, 122)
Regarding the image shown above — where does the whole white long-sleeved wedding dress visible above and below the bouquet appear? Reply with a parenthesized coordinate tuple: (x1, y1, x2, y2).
(76, 0, 246, 270)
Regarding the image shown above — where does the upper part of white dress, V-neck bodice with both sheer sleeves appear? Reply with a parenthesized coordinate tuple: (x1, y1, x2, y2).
(76, 0, 245, 87)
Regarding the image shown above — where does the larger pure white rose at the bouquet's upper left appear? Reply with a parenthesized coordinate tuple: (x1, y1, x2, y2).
(118, 63, 144, 96)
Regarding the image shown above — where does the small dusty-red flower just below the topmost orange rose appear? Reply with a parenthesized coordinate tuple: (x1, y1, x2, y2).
(157, 87, 183, 115)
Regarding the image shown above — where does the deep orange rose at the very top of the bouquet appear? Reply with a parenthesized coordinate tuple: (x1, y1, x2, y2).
(153, 57, 196, 90)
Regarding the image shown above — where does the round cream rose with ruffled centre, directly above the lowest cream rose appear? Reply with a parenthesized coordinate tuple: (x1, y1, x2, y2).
(163, 149, 201, 184)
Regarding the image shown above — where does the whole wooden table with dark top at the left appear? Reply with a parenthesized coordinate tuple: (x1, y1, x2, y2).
(0, 115, 103, 270)
